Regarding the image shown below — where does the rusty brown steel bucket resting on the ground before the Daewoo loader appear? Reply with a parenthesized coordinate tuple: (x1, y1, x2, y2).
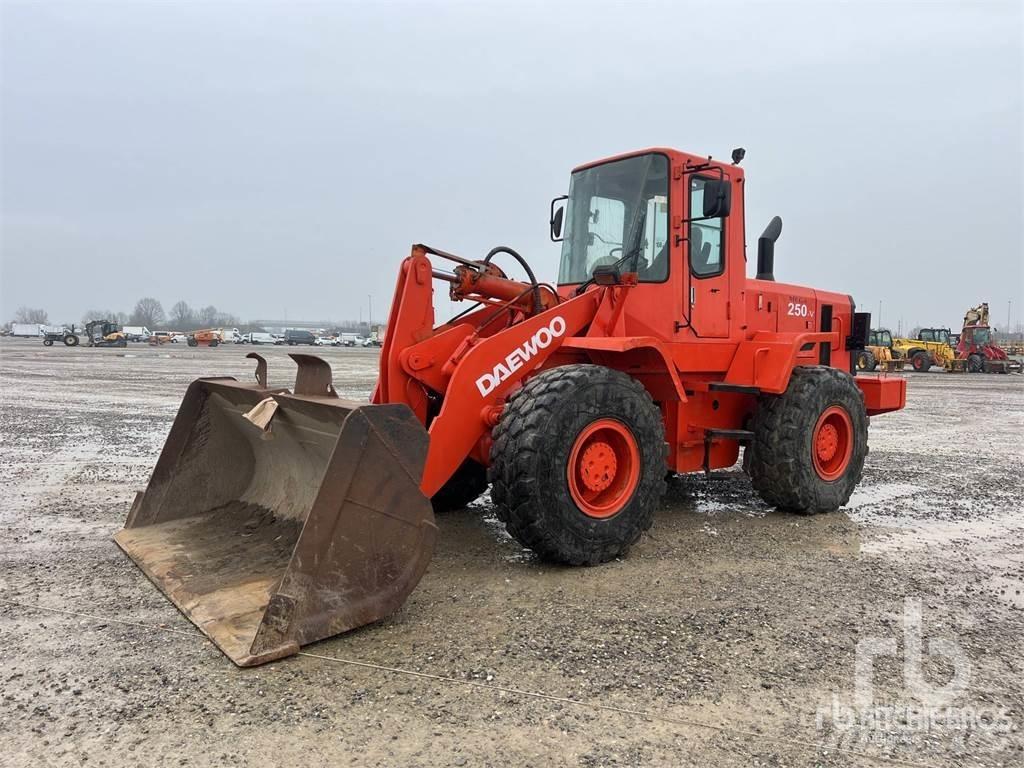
(114, 354, 436, 667)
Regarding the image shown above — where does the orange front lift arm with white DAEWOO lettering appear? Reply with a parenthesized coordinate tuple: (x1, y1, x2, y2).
(373, 245, 605, 498)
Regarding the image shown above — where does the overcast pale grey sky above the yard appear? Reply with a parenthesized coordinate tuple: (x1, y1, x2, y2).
(0, 1, 1024, 328)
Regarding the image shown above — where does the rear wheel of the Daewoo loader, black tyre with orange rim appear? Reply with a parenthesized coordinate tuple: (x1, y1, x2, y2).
(750, 367, 867, 514)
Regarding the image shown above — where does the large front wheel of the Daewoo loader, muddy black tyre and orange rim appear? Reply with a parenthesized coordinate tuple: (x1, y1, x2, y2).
(489, 365, 666, 565)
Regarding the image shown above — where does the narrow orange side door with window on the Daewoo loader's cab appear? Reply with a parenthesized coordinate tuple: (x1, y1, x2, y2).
(684, 179, 729, 338)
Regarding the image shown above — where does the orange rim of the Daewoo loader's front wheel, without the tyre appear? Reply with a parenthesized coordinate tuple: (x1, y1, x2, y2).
(567, 419, 640, 519)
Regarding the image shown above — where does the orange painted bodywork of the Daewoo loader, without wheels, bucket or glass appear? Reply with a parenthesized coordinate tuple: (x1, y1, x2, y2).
(373, 148, 906, 496)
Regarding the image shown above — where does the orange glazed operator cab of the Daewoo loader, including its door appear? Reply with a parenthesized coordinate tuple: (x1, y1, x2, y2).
(551, 148, 745, 340)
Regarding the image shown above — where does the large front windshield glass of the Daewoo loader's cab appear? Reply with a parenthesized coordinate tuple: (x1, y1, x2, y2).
(558, 155, 669, 285)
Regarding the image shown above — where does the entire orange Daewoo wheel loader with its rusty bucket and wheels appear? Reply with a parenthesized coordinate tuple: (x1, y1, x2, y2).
(116, 148, 906, 666)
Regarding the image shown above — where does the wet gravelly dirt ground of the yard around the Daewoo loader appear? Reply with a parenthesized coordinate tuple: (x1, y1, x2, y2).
(0, 339, 1024, 767)
